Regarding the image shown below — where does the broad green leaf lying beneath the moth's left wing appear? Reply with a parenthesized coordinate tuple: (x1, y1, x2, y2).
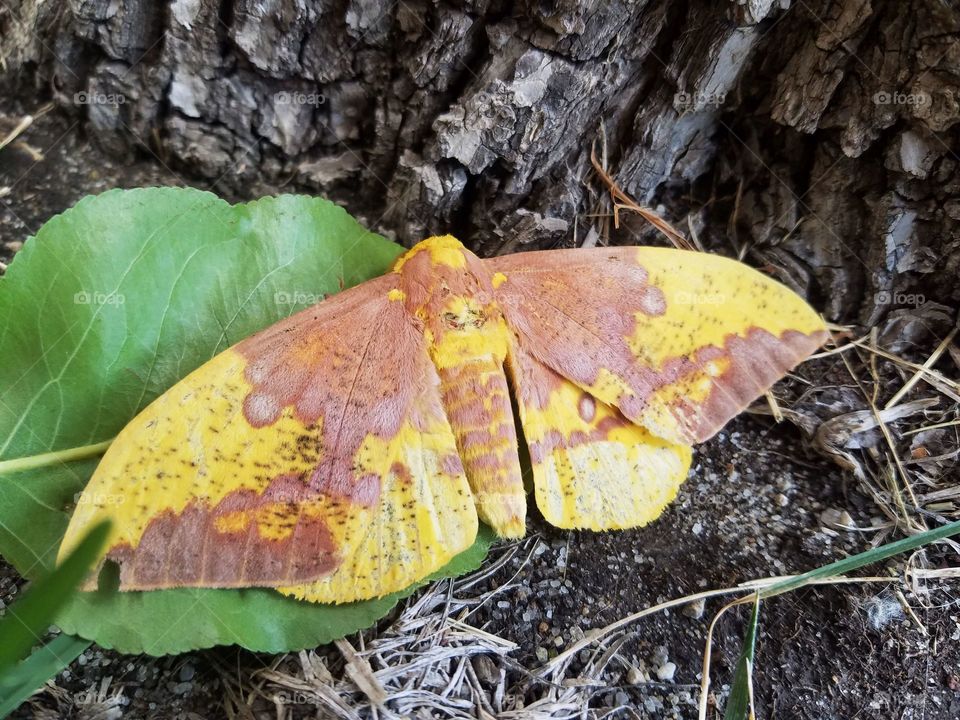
(0, 188, 489, 654)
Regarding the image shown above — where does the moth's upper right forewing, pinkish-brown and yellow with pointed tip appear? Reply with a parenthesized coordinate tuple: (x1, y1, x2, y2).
(485, 247, 827, 445)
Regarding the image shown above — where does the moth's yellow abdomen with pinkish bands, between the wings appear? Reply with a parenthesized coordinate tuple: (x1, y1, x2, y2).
(440, 357, 527, 538)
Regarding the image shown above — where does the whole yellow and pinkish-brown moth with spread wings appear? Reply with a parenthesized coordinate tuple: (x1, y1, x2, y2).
(60, 235, 827, 603)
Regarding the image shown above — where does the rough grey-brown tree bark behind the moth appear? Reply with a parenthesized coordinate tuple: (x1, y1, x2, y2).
(0, 0, 960, 332)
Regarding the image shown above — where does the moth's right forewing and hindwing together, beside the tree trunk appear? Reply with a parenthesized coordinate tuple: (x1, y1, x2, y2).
(485, 248, 826, 530)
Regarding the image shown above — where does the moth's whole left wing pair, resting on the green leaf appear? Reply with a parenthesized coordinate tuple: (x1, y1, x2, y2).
(60, 275, 477, 602)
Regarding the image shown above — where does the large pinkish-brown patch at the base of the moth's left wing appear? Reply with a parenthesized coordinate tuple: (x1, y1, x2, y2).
(236, 275, 443, 506)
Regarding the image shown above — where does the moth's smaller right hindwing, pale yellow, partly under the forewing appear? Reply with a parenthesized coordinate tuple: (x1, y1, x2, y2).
(508, 345, 691, 530)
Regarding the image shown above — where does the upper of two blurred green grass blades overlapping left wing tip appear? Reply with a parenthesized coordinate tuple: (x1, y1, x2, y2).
(0, 522, 109, 676)
